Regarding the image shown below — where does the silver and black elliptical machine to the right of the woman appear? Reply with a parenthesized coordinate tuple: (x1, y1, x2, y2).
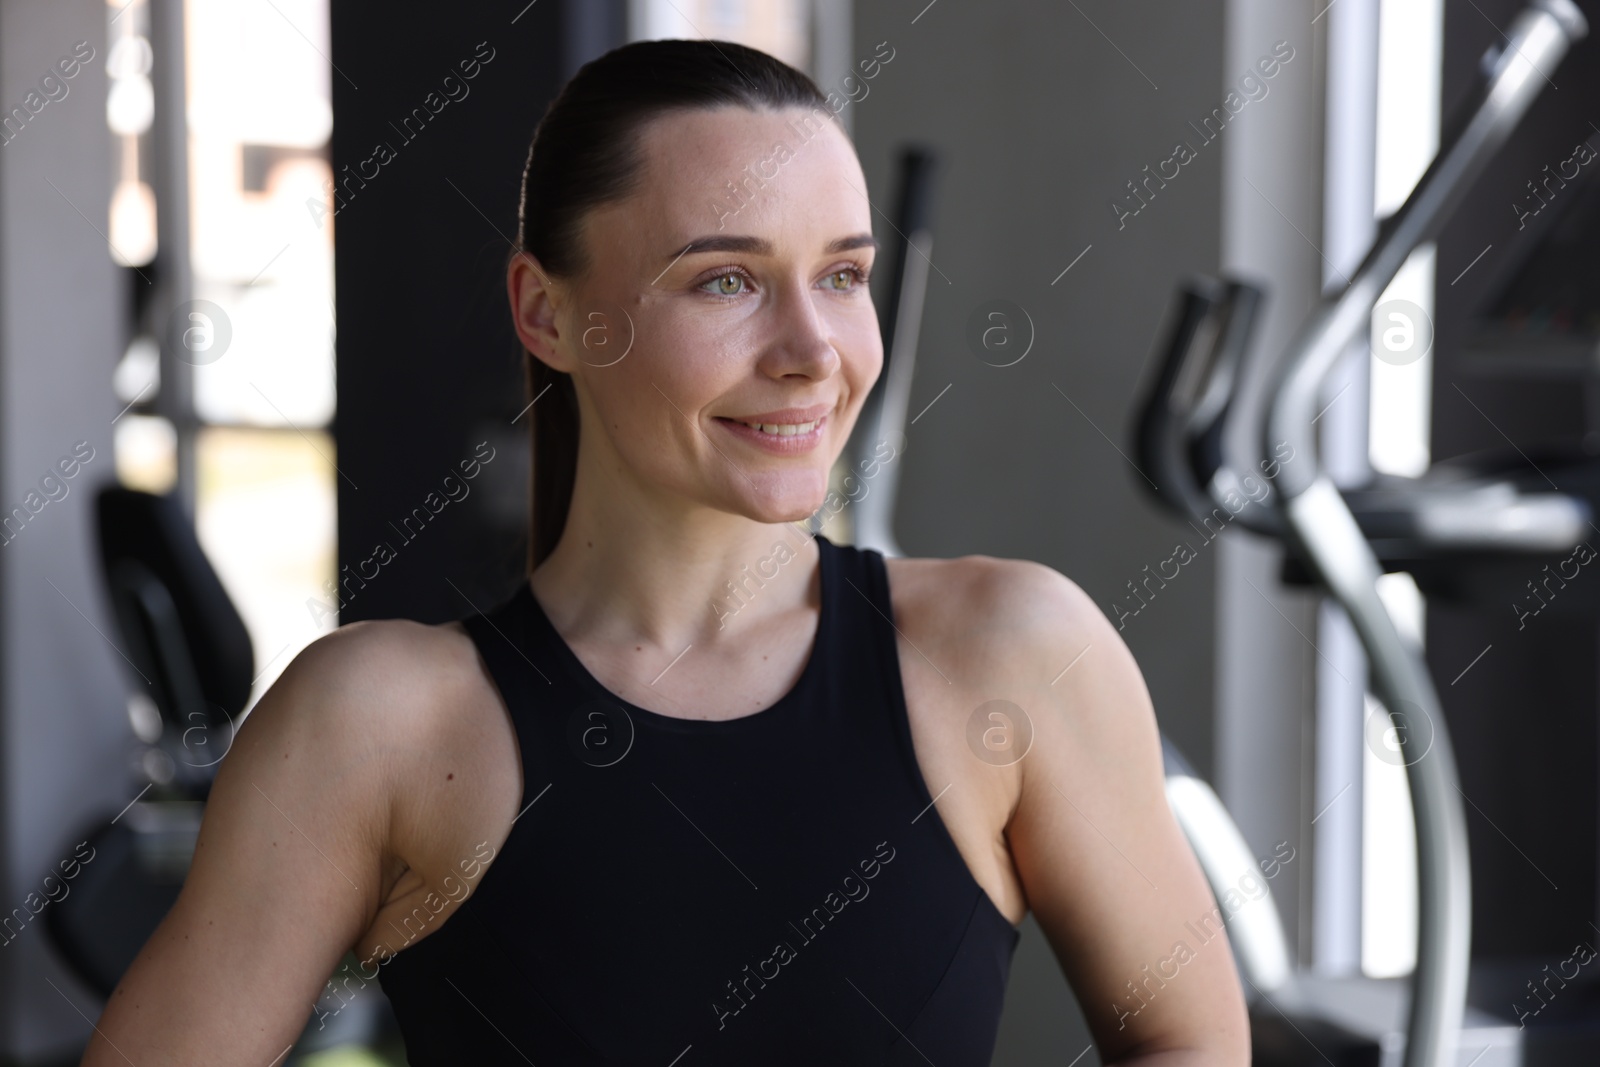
(1138, 0, 1600, 1067)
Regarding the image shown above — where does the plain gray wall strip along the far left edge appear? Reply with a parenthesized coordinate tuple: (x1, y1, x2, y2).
(0, 0, 133, 1059)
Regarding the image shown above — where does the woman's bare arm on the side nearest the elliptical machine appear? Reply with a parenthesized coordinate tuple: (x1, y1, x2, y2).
(997, 561, 1250, 1067)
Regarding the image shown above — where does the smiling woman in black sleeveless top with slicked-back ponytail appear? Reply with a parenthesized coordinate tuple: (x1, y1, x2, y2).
(83, 42, 1248, 1067)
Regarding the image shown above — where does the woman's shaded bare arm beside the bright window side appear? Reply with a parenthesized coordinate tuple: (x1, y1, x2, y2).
(82, 622, 426, 1067)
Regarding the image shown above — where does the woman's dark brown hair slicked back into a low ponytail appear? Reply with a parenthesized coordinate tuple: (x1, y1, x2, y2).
(514, 40, 834, 571)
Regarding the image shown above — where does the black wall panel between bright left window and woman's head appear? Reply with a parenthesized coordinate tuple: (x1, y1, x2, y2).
(326, 0, 622, 622)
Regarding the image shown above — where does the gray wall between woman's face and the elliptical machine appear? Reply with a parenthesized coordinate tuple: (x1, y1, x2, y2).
(851, 0, 1222, 1065)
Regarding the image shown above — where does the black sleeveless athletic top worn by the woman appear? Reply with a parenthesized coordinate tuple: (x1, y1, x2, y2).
(379, 536, 1021, 1067)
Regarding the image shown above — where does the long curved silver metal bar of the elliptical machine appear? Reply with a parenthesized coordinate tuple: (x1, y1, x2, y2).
(1261, 0, 1587, 1067)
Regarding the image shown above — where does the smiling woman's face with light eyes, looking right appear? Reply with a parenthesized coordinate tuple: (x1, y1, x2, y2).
(510, 107, 883, 523)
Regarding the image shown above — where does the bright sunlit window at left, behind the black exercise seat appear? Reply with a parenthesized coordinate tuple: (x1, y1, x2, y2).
(107, 0, 338, 704)
